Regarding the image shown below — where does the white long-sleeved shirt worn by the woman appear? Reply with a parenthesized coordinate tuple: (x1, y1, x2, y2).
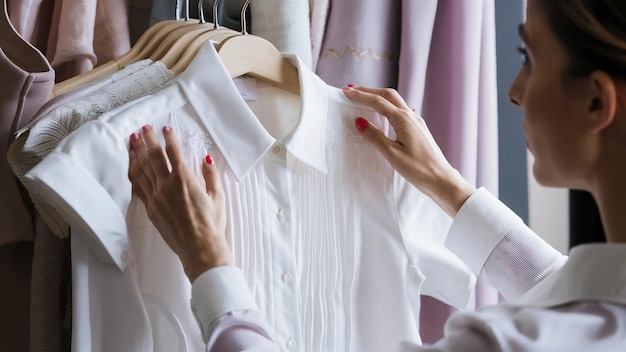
(192, 188, 626, 352)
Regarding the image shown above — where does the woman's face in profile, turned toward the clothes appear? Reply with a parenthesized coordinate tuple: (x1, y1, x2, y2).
(502, 0, 588, 188)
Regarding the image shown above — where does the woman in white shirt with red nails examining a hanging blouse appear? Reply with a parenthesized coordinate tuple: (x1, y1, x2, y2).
(129, 0, 626, 351)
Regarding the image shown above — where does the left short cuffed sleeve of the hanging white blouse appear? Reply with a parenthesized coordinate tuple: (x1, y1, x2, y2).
(25, 120, 133, 271)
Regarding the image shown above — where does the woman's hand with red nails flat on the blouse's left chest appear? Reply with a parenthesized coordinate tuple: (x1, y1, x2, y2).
(128, 126, 233, 283)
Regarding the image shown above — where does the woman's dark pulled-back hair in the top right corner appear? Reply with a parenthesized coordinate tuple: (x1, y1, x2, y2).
(539, 0, 626, 82)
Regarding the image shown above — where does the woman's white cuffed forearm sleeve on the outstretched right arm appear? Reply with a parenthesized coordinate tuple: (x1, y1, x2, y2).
(446, 188, 567, 301)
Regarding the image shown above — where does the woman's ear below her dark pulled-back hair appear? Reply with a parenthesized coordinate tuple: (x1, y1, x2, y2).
(587, 71, 618, 132)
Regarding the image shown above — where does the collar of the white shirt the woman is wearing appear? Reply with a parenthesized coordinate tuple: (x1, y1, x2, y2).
(518, 243, 626, 307)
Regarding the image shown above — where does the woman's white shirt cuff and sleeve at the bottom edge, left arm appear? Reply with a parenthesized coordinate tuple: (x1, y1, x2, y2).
(191, 266, 279, 352)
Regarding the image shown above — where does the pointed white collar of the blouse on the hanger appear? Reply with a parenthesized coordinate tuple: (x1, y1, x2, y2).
(178, 42, 327, 181)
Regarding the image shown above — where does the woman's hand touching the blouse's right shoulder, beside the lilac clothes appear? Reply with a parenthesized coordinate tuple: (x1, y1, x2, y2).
(343, 87, 476, 217)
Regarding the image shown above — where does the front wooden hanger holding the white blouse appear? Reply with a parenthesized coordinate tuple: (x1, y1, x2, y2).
(217, 0, 300, 95)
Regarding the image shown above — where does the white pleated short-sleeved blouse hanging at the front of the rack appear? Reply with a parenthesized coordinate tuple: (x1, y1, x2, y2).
(26, 44, 475, 351)
